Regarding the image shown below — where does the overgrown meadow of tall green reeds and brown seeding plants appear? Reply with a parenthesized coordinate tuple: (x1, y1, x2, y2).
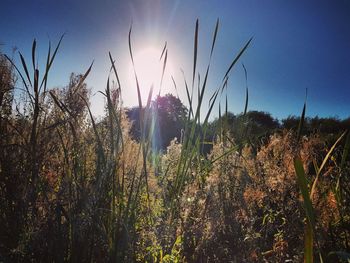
(0, 21, 350, 262)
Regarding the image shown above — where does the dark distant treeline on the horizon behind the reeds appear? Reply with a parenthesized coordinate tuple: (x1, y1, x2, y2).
(126, 94, 350, 153)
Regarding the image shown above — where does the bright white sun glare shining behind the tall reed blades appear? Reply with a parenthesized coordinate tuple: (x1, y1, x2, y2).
(128, 46, 174, 101)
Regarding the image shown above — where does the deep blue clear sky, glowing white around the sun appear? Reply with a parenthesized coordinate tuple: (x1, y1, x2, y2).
(0, 0, 350, 119)
